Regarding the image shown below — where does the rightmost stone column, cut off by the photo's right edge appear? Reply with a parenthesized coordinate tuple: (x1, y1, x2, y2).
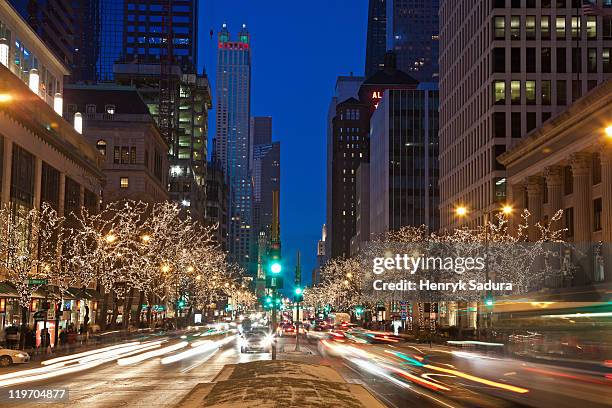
(600, 145, 612, 282)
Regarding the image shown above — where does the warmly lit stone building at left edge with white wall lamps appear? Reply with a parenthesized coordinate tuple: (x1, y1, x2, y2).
(0, 2, 104, 338)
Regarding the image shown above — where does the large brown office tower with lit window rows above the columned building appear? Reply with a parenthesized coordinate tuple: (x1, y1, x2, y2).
(440, 0, 612, 228)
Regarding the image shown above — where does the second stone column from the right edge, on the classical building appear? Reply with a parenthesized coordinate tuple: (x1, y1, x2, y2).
(570, 152, 593, 286)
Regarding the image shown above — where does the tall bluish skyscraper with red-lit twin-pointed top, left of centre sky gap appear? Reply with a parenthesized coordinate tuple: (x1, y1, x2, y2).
(215, 24, 256, 274)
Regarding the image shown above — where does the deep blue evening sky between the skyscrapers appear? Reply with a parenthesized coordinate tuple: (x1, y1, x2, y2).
(198, 0, 367, 290)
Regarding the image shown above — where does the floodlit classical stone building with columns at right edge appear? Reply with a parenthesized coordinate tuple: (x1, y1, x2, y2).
(498, 80, 612, 286)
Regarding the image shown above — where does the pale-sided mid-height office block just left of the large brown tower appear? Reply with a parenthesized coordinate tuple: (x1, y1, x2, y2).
(369, 84, 439, 235)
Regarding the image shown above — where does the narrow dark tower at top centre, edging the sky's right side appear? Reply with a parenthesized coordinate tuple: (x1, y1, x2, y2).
(365, 0, 392, 76)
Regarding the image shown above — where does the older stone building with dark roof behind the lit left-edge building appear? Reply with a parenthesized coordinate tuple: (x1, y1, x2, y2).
(64, 85, 170, 203)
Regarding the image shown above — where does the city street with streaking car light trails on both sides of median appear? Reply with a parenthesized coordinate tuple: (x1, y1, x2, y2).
(0, 334, 612, 408)
